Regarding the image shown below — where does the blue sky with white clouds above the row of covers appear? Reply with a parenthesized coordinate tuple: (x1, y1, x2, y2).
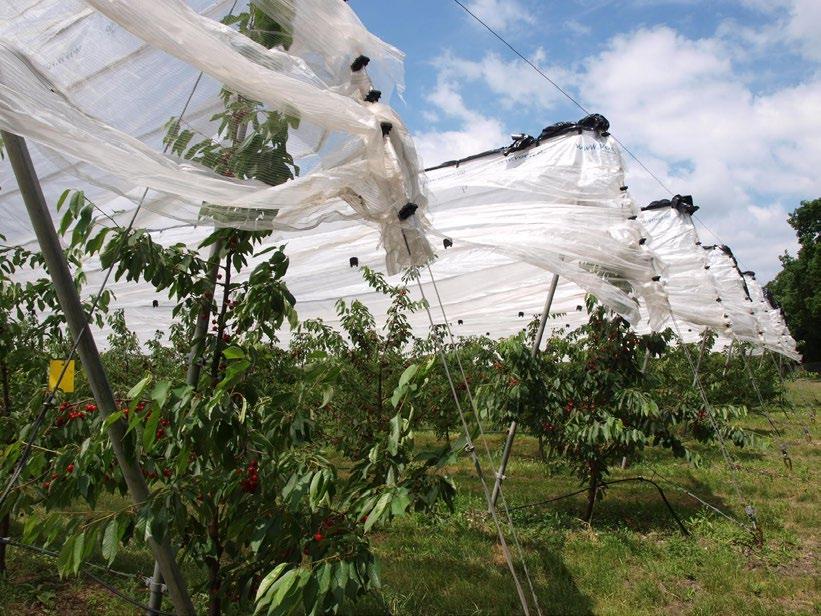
(349, 0, 821, 282)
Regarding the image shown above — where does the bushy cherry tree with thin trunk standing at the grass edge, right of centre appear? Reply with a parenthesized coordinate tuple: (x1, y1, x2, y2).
(480, 297, 747, 519)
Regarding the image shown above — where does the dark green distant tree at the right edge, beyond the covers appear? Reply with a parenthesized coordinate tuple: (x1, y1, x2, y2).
(767, 198, 821, 362)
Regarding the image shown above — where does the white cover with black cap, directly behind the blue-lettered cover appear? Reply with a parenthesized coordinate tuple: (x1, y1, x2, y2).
(639, 201, 730, 335)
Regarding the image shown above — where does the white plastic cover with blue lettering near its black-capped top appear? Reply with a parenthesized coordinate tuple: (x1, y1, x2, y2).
(420, 130, 669, 322)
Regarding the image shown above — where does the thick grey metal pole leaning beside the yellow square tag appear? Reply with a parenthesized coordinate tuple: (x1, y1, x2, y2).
(0, 131, 194, 616)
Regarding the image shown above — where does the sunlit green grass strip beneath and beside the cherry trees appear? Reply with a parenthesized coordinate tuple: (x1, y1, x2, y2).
(0, 380, 821, 616)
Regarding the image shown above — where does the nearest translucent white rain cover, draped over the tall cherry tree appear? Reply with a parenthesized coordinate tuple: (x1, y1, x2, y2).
(0, 0, 431, 272)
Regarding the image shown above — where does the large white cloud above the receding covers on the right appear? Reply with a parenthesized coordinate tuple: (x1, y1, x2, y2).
(581, 27, 821, 280)
